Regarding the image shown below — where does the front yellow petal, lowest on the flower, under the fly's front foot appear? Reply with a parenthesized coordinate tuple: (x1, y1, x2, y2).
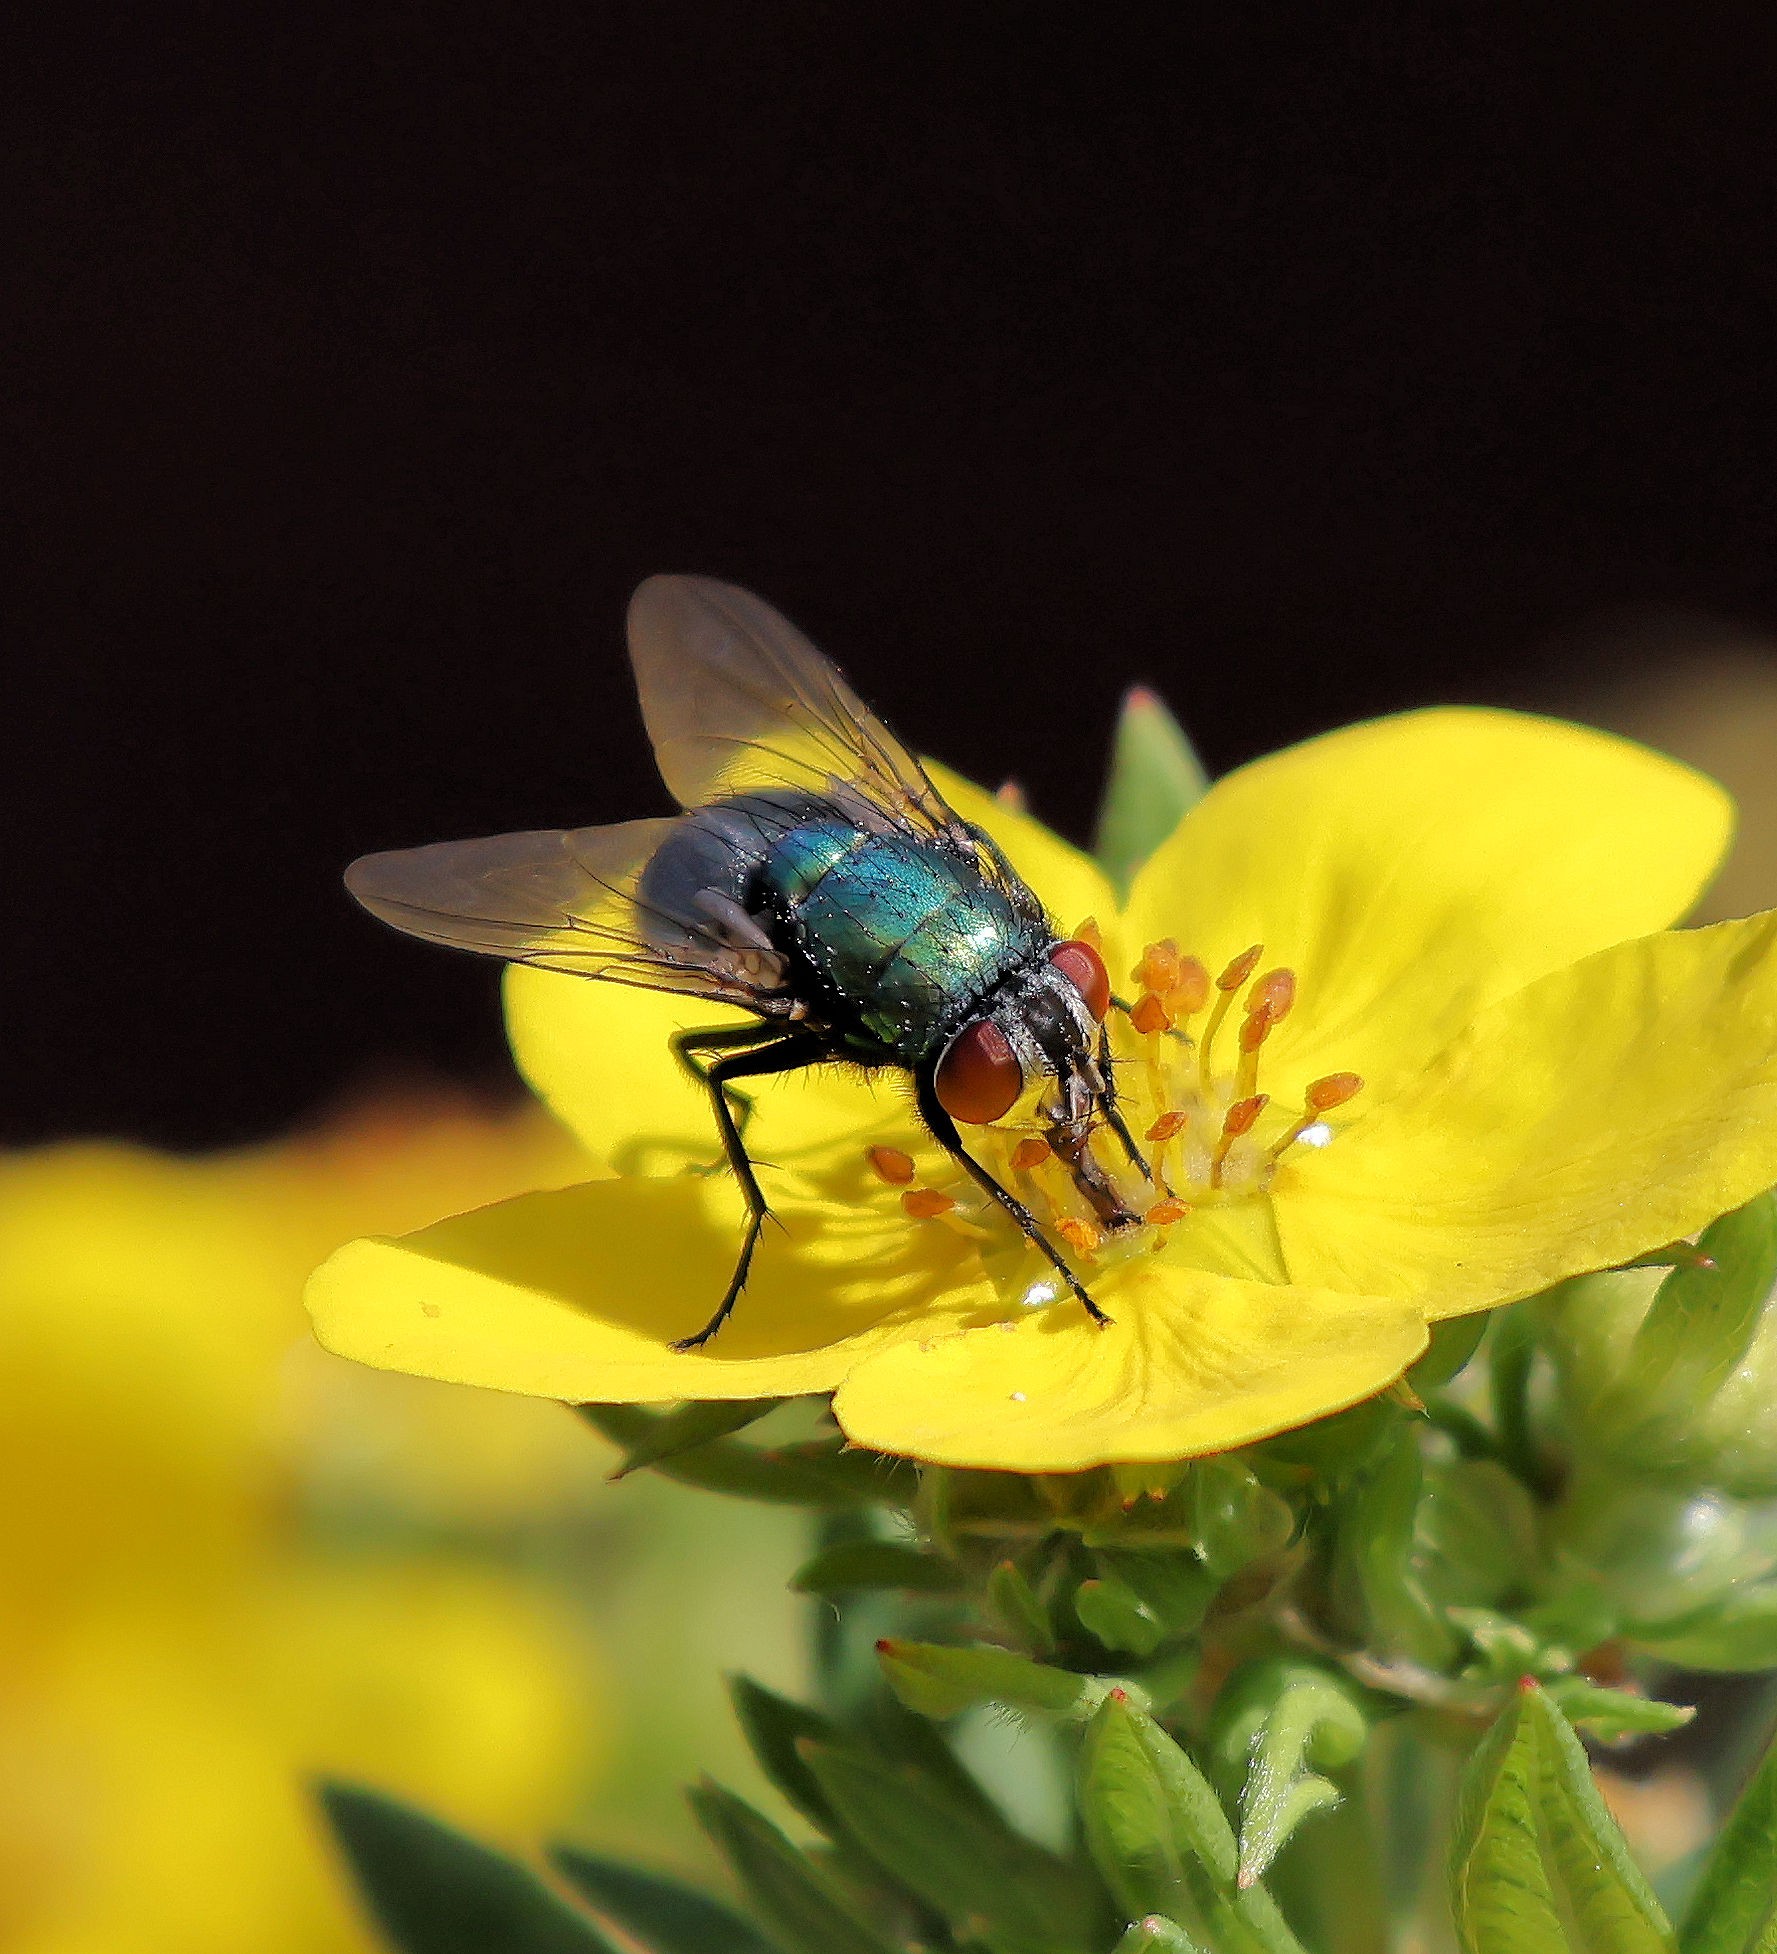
(835, 1256, 1425, 1471)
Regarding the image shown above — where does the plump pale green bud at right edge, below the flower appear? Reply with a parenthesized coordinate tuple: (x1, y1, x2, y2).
(1539, 1194, 1777, 1499)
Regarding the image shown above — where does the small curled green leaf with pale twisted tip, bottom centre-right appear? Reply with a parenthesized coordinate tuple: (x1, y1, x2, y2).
(1208, 1659, 1370, 1884)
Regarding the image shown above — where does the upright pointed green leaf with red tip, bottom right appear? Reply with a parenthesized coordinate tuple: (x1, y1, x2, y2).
(1451, 1682, 1675, 1954)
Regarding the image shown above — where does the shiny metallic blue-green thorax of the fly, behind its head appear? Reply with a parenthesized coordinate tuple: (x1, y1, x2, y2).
(760, 815, 1048, 1065)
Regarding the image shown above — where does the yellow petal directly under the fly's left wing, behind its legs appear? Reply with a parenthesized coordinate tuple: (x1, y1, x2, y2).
(506, 965, 913, 1174)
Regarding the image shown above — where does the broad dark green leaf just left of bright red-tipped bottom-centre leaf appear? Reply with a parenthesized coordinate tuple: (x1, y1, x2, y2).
(803, 1743, 1099, 1954)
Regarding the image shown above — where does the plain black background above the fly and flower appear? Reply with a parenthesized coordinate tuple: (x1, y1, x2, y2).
(13, 11, 1777, 1145)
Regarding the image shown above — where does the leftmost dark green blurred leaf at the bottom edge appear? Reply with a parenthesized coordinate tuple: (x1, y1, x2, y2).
(321, 1782, 616, 1954)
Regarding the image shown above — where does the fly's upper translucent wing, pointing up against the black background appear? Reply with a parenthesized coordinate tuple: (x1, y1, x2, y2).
(629, 576, 966, 842)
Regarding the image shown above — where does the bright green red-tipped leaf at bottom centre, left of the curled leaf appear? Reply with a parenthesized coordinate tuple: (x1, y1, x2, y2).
(1079, 1690, 1300, 1954)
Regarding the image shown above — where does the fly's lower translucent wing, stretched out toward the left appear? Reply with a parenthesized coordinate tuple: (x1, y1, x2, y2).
(346, 821, 792, 1014)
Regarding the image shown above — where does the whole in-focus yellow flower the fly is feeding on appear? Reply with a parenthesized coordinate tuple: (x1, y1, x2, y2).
(309, 709, 1777, 1469)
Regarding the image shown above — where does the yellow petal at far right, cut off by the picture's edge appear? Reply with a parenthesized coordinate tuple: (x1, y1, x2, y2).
(1273, 913, 1777, 1317)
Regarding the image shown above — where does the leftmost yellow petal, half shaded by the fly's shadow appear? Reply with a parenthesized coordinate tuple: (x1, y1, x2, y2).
(307, 1178, 997, 1403)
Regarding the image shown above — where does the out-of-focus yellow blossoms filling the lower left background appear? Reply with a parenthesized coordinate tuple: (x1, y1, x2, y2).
(0, 1108, 604, 1954)
